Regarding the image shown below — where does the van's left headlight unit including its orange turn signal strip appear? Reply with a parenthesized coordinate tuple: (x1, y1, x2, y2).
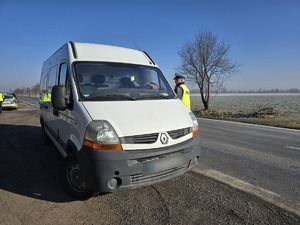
(84, 120, 123, 150)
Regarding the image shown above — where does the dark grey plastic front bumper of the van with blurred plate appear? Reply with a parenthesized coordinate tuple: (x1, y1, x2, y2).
(77, 135, 200, 193)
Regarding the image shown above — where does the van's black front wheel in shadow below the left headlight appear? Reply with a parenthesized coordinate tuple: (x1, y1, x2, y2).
(63, 153, 96, 200)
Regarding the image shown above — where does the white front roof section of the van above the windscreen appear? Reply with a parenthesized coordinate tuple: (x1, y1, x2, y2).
(69, 42, 155, 66)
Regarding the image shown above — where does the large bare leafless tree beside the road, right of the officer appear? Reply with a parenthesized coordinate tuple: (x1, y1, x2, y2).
(178, 31, 239, 110)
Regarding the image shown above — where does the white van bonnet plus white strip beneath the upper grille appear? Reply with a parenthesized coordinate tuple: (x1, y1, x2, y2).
(83, 99, 192, 150)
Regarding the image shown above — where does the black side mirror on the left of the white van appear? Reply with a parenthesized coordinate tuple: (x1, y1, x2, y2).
(51, 85, 67, 110)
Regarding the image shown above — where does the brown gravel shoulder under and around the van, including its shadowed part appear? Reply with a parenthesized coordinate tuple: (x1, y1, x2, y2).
(0, 105, 300, 225)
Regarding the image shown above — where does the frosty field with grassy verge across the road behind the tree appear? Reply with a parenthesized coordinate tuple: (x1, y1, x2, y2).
(191, 94, 300, 129)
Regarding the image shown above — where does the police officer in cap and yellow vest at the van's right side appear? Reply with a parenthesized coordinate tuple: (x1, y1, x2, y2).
(174, 73, 191, 109)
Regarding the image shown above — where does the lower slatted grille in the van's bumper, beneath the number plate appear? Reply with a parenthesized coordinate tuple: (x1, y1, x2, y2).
(130, 162, 190, 184)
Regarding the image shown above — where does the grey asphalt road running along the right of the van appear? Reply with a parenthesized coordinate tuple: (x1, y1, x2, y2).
(198, 119, 300, 214)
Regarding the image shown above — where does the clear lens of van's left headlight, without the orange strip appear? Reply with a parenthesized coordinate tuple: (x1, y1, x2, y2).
(85, 120, 119, 144)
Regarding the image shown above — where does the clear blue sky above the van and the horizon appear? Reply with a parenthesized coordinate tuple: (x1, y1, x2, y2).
(0, 0, 300, 91)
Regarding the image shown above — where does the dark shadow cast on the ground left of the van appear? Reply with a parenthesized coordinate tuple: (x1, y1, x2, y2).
(0, 124, 74, 202)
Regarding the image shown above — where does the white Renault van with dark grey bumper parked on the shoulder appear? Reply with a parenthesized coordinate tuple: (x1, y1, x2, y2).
(40, 42, 200, 199)
